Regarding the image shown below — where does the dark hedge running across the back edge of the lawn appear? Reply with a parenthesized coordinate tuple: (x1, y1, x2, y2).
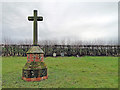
(0, 44, 120, 57)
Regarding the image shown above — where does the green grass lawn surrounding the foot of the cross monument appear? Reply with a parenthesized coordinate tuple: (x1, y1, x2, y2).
(2, 56, 118, 88)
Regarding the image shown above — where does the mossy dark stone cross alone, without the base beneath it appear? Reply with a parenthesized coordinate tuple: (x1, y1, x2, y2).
(28, 10, 43, 45)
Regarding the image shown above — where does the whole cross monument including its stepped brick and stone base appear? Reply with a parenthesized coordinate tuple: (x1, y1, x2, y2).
(22, 10, 48, 81)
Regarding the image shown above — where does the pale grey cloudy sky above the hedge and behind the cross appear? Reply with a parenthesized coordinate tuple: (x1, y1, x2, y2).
(2, 1, 118, 44)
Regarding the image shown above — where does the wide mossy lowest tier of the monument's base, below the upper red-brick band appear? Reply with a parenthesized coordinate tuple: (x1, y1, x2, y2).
(22, 61, 48, 81)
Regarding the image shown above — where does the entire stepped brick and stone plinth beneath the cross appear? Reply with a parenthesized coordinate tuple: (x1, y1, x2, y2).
(22, 46, 48, 81)
